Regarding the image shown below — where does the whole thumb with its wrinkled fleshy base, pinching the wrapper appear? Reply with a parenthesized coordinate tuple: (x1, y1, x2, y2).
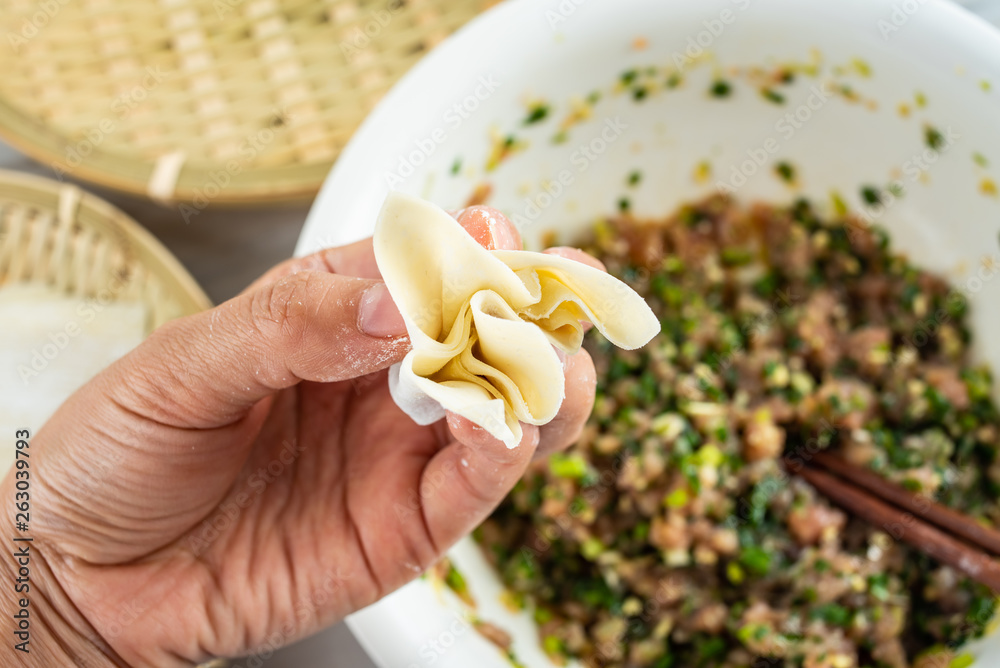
(34, 272, 409, 563)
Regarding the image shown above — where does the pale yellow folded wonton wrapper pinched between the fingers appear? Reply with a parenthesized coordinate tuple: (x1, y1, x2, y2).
(374, 193, 660, 448)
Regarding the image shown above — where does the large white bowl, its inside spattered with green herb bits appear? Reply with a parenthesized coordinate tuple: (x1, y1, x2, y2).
(298, 0, 1000, 668)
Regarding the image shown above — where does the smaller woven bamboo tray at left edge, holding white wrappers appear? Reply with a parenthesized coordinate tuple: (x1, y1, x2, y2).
(0, 170, 211, 333)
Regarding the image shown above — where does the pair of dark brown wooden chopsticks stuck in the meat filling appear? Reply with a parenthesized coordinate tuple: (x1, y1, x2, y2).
(790, 454, 1000, 591)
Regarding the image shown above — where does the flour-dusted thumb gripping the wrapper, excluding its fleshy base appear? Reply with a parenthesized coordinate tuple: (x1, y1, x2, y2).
(101, 271, 409, 429)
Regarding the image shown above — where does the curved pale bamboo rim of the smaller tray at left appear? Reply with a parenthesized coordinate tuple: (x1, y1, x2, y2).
(0, 169, 212, 315)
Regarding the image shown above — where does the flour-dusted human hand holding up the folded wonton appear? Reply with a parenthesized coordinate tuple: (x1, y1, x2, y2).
(0, 207, 599, 666)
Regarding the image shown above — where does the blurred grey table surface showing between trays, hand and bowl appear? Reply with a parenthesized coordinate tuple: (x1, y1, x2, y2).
(0, 0, 1000, 668)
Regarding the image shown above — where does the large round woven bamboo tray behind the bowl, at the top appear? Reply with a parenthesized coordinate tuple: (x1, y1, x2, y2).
(0, 0, 496, 208)
